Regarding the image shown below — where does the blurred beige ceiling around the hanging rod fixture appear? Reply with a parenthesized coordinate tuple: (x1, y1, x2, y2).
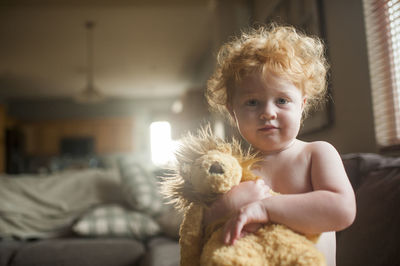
(0, 0, 250, 101)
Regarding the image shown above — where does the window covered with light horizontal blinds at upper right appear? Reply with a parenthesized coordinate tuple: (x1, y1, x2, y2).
(364, 0, 400, 148)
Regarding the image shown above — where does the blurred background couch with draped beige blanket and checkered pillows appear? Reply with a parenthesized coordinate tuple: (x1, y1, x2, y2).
(0, 156, 182, 266)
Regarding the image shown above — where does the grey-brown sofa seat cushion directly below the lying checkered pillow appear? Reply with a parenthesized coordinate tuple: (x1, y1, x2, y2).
(10, 239, 145, 266)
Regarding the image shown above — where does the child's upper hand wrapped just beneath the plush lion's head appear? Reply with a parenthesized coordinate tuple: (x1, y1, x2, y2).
(203, 179, 270, 225)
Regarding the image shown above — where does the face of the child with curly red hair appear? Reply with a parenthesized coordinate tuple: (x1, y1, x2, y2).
(229, 72, 305, 154)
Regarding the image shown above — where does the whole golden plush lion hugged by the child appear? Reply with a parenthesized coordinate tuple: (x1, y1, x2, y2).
(162, 126, 325, 266)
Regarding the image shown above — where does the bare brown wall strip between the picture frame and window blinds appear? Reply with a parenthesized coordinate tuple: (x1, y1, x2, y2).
(306, 0, 377, 153)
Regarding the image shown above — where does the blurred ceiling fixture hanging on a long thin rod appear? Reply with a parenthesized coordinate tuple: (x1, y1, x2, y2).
(75, 21, 105, 103)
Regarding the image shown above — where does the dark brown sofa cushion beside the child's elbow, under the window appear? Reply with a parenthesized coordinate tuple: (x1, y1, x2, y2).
(337, 166, 400, 266)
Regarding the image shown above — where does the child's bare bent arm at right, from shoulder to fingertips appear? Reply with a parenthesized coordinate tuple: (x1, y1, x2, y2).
(224, 142, 356, 243)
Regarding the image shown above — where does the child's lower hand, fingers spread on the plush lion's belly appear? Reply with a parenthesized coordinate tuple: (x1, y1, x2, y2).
(223, 200, 269, 245)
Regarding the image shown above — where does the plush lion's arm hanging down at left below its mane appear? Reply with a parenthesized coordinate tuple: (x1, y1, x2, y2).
(179, 203, 203, 266)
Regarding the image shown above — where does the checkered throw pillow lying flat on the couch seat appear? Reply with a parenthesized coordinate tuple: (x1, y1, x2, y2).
(73, 205, 161, 240)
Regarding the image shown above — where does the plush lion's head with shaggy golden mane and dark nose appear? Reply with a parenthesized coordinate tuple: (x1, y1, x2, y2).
(164, 126, 255, 209)
